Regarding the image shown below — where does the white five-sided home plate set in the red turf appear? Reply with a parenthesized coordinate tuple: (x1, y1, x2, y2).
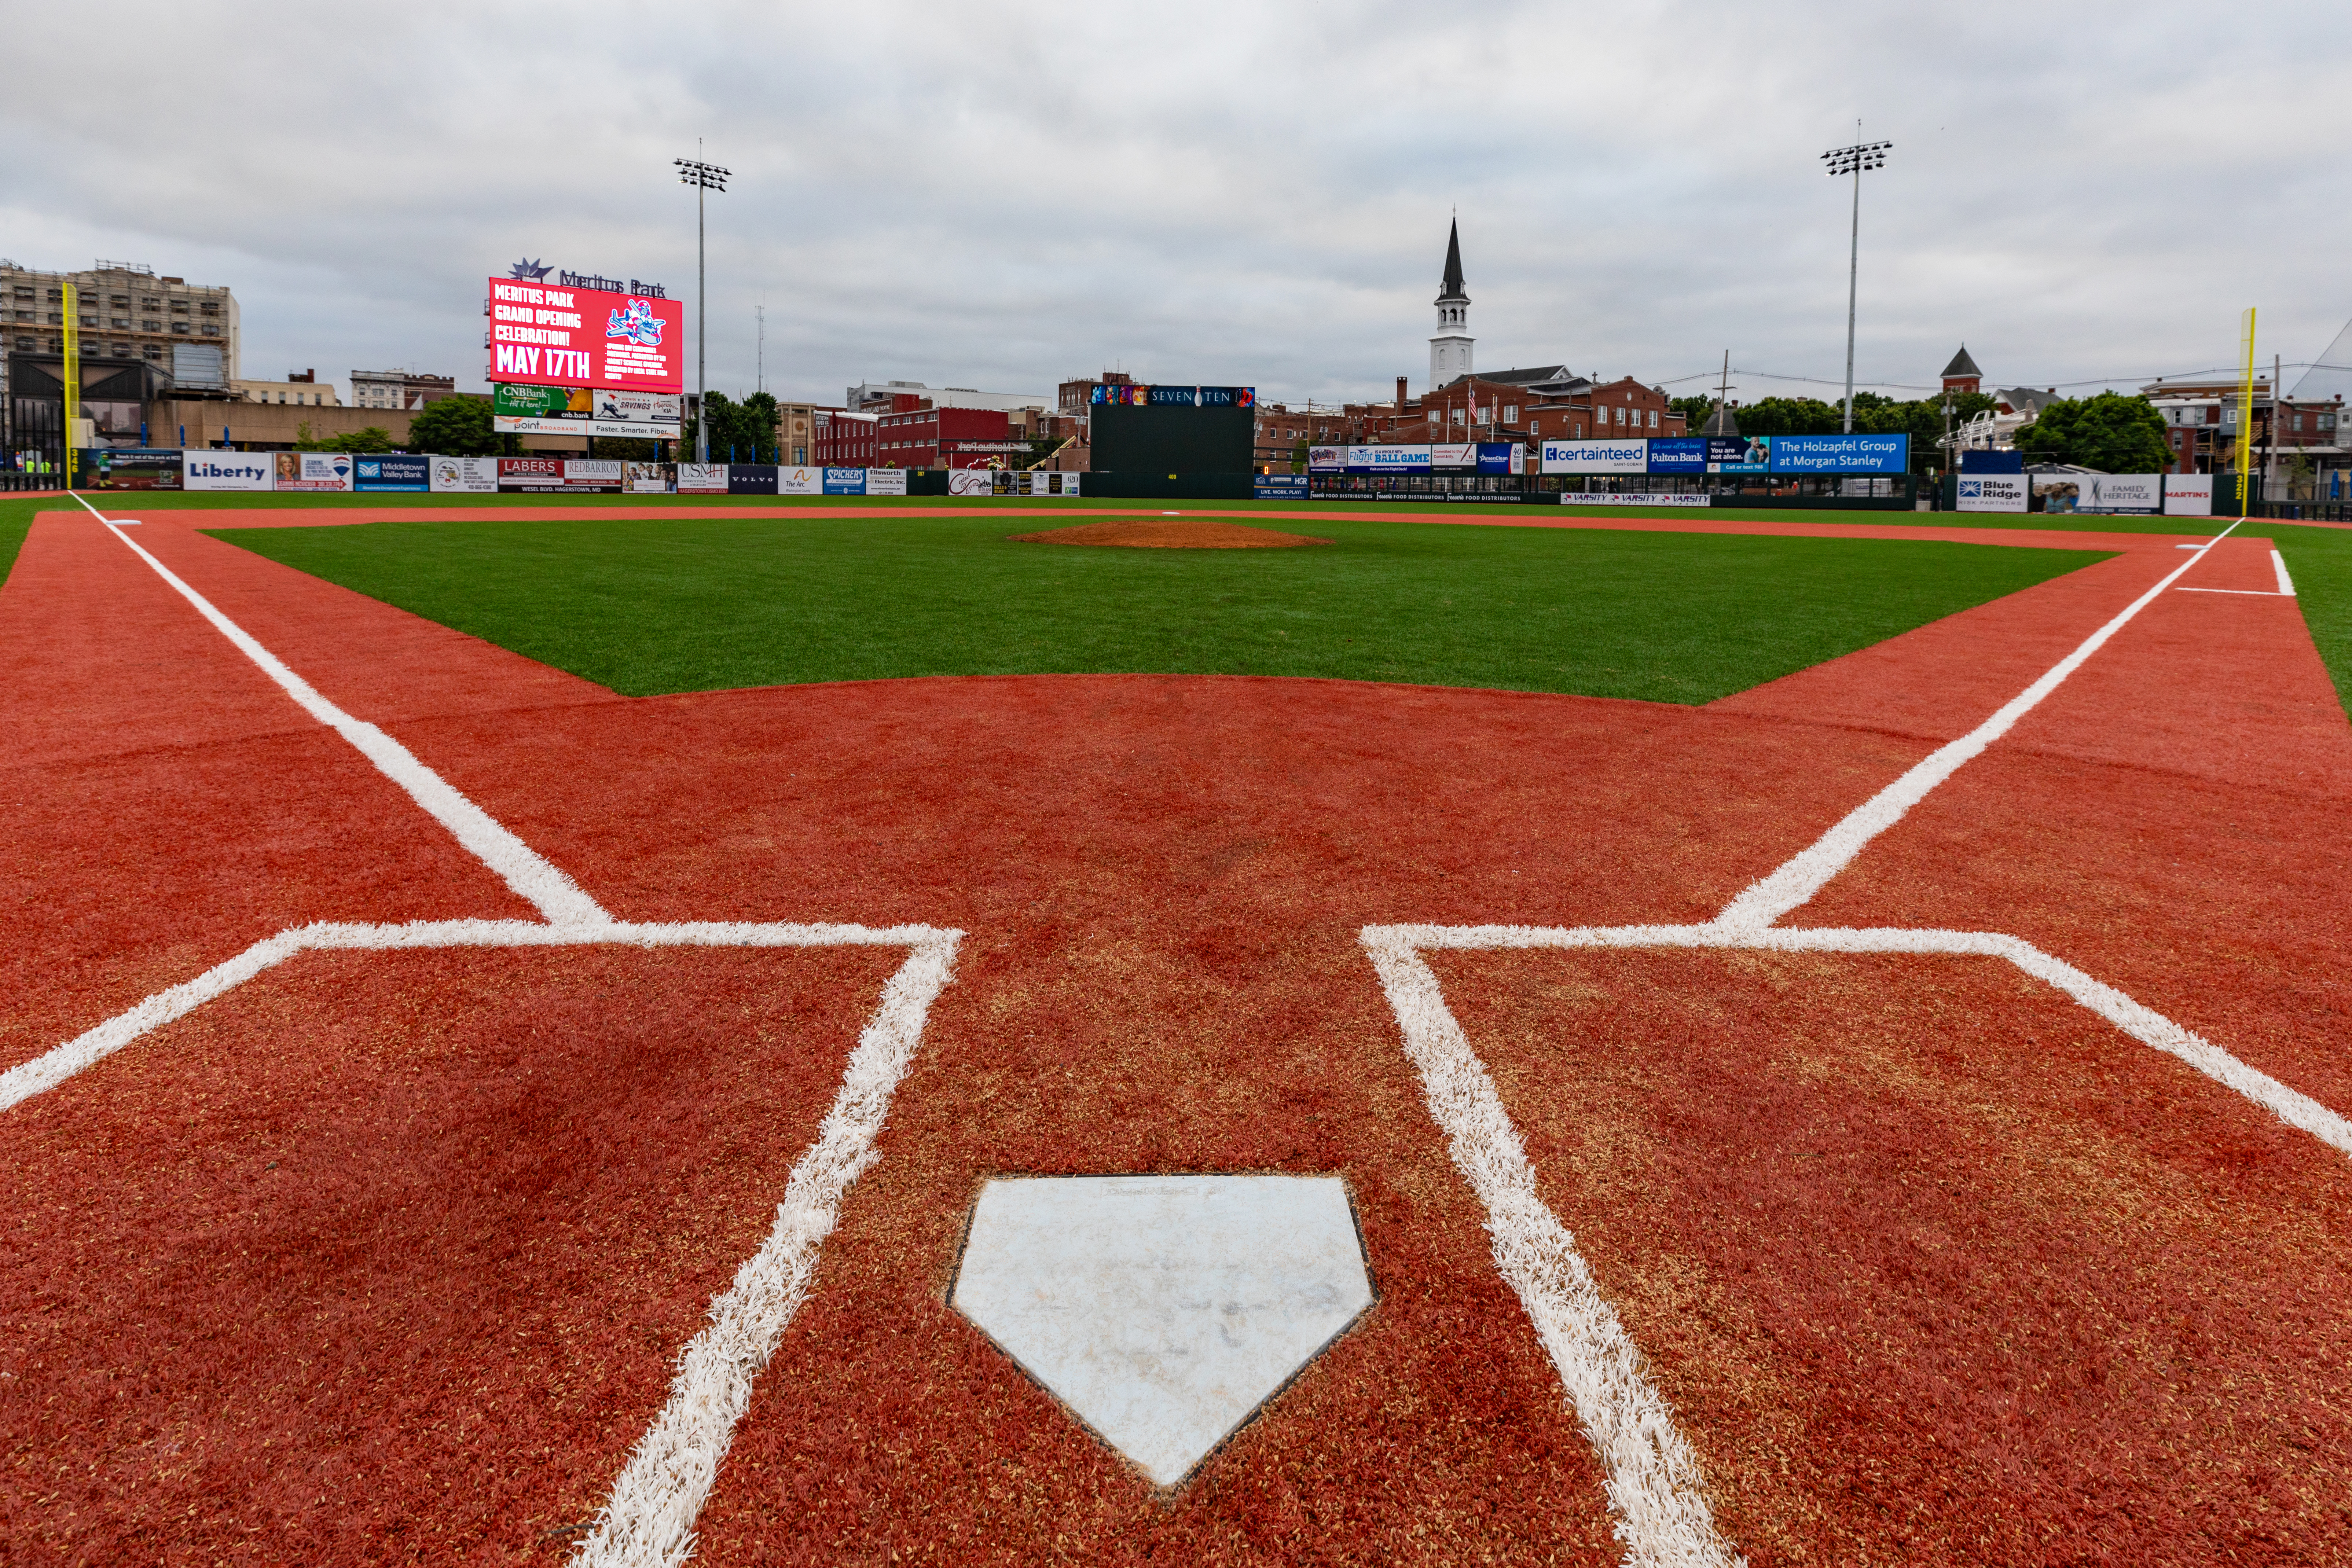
(950, 1175, 1371, 1486)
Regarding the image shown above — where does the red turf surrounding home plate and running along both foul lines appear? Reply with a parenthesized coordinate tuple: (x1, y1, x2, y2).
(0, 508, 2352, 1563)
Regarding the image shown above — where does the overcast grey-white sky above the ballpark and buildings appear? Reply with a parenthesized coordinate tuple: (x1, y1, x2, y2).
(18, 0, 2352, 414)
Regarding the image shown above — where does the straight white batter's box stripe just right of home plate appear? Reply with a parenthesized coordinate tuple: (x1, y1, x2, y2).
(1362, 926, 1740, 1568)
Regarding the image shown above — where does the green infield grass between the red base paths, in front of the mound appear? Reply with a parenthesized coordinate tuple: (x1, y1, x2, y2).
(193, 508, 2100, 703)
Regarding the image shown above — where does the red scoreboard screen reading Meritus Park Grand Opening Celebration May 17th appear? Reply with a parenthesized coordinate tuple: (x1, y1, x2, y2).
(489, 278, 687, 395)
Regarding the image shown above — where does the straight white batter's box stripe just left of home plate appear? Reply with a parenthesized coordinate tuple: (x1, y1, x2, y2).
(572, 931, 962, 1568)
